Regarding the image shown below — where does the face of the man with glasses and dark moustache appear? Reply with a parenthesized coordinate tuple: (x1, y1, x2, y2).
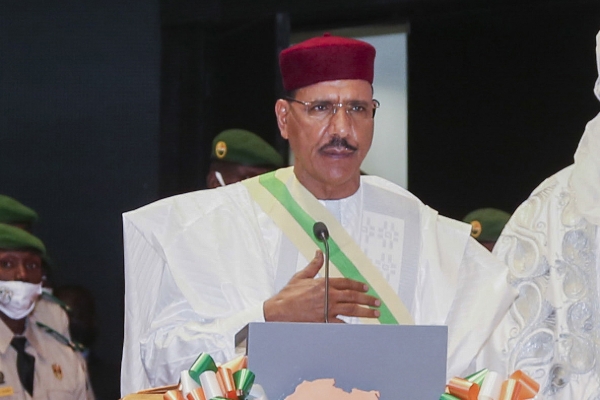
(275, 80, 374, 199)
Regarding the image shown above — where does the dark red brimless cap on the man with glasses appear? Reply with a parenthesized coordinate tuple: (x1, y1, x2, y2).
(279, 33, 375, 91)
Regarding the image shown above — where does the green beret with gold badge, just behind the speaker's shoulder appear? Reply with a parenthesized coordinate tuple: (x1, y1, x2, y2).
(211, 129, 283, 168)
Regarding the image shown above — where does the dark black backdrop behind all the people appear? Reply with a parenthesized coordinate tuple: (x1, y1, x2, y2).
(0, 0, 600, 396)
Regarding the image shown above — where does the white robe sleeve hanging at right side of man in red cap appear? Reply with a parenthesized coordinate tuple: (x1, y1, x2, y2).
(415, 206, 516, 379)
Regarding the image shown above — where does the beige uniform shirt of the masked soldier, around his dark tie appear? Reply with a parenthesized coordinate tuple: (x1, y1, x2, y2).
(0, 314, 89, 400)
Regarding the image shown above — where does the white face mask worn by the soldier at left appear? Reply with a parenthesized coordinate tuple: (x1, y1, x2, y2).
(0, 281, 42, 320)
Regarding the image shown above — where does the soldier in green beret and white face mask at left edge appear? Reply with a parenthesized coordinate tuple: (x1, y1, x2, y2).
(0, 224, 88, 400)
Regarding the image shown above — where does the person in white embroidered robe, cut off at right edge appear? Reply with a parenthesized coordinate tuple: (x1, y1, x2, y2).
(479, 29, 600, 400)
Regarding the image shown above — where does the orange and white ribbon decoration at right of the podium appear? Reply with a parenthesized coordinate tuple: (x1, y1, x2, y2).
(440, 369, 540, 400)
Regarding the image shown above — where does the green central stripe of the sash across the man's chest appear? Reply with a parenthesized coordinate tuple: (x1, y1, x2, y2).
(259, 172, 398, 325)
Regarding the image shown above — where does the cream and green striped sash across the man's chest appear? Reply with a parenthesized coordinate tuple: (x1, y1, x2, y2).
(243, 167, 413, 325)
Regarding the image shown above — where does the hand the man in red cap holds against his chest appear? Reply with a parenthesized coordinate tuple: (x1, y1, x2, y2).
(263, 250, 381, 322)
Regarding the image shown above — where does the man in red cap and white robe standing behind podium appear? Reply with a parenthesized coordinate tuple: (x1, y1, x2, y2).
(121, 35, 516, 394)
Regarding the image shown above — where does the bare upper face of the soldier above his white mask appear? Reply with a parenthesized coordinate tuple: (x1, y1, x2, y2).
(0, 250, 42, 284)
